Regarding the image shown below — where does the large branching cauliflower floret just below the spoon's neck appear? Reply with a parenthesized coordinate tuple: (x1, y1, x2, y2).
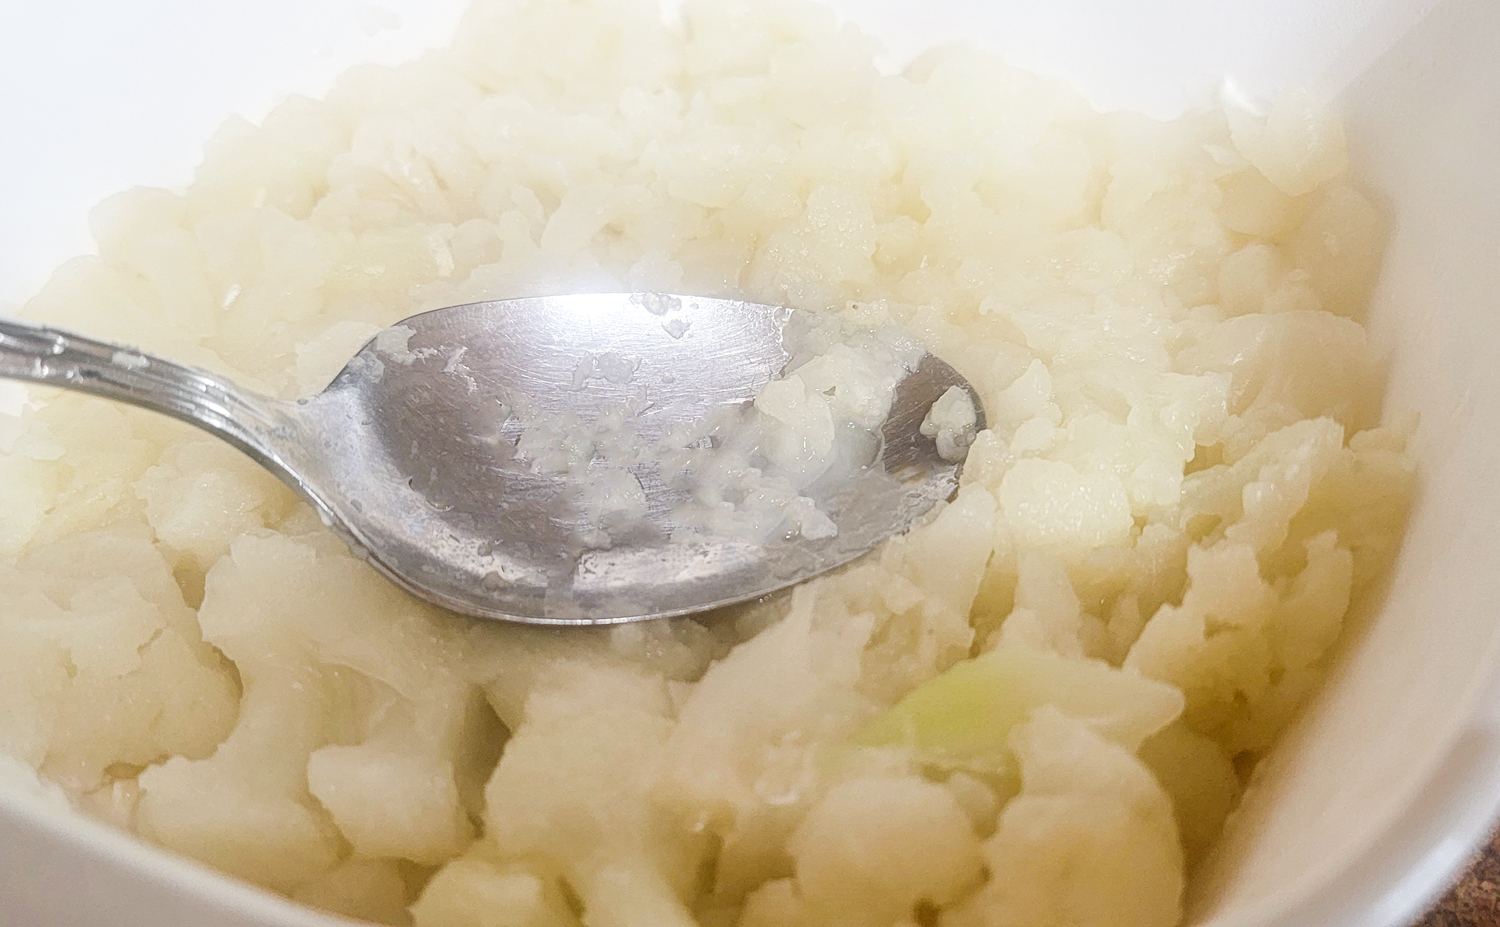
(140, 522, 483, 890)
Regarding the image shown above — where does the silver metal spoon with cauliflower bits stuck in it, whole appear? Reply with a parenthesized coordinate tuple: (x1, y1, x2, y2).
(0, 294, 984, 624)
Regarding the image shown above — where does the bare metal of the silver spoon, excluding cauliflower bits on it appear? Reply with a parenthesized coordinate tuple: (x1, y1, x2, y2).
(0, 294, 984, 624)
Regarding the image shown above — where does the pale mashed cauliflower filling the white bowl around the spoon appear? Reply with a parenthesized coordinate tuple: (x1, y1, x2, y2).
(0, 0, 1413, 927)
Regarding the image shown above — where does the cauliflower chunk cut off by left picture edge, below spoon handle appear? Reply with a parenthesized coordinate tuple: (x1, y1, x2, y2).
(0, 525, 239, 792)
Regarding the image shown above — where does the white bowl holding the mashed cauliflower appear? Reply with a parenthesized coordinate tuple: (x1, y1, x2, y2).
(0, 0, 1500, 927)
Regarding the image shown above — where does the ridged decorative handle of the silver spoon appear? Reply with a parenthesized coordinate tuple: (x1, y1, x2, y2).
(0, 318, 293, 471)
